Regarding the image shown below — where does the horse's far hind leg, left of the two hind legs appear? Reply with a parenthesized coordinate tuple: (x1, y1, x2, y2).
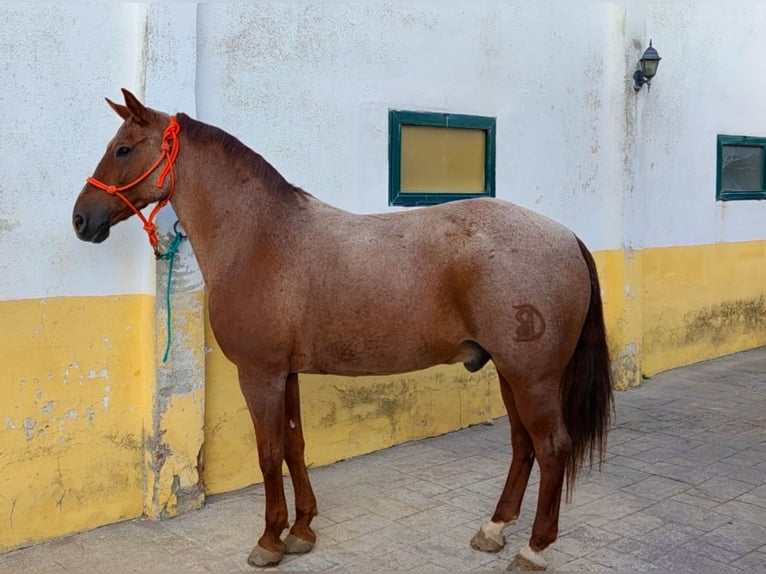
(471, 373, 535, 552)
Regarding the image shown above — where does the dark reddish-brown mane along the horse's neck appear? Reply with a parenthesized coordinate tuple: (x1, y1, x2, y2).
(176, 113, 309, 200)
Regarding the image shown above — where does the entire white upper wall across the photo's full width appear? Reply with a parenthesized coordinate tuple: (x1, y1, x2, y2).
(0, 0, 766, 300)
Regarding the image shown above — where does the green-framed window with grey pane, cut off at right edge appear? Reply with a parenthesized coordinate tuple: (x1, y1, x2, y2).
(715, 135, 766, 201)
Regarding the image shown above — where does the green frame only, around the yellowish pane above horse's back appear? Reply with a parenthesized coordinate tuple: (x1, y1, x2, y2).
(388, 110, 497, 206)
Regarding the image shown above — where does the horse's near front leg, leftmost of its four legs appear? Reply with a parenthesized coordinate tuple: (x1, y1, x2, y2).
(239, 366, 288, 566)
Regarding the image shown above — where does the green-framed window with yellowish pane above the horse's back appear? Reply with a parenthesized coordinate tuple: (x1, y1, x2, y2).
(388, 110, 496, 205)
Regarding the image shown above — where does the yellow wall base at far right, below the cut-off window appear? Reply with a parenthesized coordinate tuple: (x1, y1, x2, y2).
(641, 241, 766, 375)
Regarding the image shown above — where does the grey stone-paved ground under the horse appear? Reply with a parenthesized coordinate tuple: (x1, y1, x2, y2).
(0, 347, 766, 571)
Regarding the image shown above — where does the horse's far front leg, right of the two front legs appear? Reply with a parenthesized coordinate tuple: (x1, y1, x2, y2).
(284, 373, 317, 554)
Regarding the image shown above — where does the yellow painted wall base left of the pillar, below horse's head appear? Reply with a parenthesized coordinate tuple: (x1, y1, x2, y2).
(0, 295, 154, 551)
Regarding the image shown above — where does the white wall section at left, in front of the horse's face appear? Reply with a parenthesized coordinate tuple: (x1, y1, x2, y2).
(0, 4, 154, 300)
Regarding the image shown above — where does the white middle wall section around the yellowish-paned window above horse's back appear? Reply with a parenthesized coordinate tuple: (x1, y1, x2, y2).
(197, 1, 620, 248)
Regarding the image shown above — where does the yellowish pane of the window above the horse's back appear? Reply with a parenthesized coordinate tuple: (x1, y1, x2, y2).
(401, 125, 486, 193)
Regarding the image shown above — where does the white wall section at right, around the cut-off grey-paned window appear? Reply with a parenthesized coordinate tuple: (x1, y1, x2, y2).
(636, 1, 766, 247)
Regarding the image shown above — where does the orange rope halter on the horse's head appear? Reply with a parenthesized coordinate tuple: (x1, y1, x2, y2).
(87, 116, 181, 258)
